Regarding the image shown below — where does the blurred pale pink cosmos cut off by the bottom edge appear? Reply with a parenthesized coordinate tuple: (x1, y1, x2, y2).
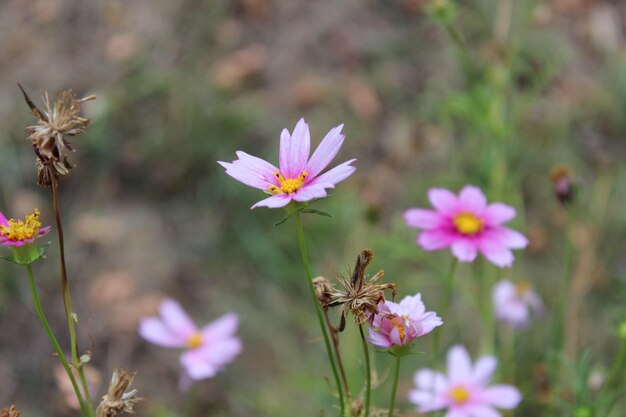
(409, 346, 522, 417)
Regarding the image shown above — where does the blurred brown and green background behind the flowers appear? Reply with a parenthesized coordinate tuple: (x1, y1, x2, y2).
(0, 0, 626, 417)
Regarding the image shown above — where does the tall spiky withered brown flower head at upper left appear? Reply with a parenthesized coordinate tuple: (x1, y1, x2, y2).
(18, 84, 96, 187)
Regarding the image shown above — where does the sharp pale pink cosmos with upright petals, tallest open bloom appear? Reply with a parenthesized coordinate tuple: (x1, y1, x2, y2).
(218, 119, 356, 208)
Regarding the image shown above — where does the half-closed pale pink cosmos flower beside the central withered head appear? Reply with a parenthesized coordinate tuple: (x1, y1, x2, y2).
(367, 293, 443, 349)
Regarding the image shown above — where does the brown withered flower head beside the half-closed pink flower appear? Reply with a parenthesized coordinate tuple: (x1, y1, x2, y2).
(326, 249, 396, 331)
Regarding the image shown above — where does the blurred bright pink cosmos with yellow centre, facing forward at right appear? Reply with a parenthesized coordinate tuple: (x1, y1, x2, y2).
(404, 185, 528, 268)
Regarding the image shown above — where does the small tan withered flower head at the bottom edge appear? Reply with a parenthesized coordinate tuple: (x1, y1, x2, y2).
(96, 369, 143, 417)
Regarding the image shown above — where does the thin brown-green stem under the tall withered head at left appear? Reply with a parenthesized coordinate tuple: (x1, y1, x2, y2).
(48, 167, 95, 417)
